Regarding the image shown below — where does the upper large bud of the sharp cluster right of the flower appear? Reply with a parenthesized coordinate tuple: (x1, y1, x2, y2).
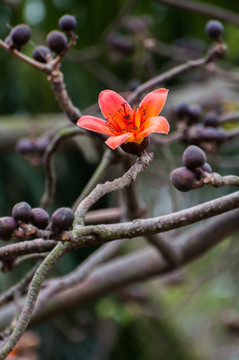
(183, 145, 207, 170)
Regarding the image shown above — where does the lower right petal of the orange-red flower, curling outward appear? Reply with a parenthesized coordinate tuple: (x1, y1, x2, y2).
(137, 116, 170, 138)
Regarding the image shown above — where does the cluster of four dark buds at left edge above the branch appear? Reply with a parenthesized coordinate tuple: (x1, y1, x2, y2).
(0, 201, 74, 241)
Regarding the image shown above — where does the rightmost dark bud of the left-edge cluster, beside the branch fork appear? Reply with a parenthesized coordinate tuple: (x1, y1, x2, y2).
(51, 207, 74, 232)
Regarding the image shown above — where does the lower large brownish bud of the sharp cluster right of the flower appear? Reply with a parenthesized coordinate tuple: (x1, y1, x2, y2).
(170, 167, 195, 192)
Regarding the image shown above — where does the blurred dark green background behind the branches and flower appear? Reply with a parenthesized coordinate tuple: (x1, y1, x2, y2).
(0, 0, 239, 360)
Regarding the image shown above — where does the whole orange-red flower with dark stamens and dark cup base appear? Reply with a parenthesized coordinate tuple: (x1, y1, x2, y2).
(77, 89, 169, 154)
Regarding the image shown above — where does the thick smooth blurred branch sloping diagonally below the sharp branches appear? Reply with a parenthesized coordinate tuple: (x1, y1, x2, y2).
(27, 210, 239, 324)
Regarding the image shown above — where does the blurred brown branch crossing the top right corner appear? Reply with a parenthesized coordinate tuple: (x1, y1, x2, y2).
(156, 0, 239, 25)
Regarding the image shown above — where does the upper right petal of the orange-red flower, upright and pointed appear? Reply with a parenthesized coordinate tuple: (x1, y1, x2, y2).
(136, 89, 168, 126)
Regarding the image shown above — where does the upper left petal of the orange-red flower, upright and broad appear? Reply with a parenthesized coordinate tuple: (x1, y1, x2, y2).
(99, 90, 133, 127)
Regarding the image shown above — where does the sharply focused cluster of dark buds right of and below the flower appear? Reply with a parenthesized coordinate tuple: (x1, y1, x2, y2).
(170, 145, 212, 192)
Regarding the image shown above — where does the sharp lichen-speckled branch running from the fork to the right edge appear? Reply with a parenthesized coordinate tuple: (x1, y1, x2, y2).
(71, 191, 239, 245)
